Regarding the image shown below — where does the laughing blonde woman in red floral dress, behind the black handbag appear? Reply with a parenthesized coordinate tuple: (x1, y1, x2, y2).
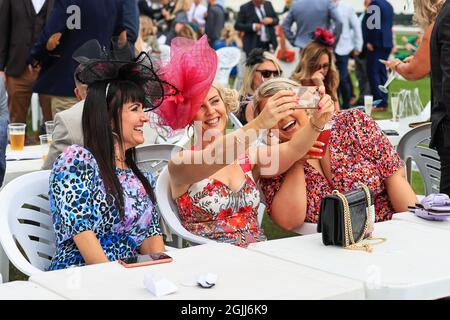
(253, 78, 416, 230)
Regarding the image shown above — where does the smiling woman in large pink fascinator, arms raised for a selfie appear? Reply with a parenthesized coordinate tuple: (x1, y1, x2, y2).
(154, 37, 334, 247)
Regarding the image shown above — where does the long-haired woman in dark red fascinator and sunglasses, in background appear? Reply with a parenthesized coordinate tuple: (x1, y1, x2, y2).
(291, 30, 339, 110)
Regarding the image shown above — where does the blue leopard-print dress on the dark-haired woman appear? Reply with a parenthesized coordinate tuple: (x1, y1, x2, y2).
(48, 145, 161, 270)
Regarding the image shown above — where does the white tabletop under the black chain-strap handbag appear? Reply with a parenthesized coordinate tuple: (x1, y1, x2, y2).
(249, 221, 450, 299)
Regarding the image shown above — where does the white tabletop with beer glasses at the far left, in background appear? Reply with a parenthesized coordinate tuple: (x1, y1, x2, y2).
(3, 145, 44, 185)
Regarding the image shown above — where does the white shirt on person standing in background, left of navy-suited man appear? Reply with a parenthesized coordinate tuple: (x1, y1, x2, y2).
(335, 1, 363, 56)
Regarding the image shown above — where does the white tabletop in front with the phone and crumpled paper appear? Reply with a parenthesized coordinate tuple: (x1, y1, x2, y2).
(30, 244, 364, 300)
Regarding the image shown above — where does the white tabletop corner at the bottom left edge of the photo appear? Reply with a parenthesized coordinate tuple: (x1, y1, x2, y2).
(0, 281, 63, 300)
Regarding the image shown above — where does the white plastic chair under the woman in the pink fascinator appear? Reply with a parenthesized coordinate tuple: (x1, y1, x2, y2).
(156, 167, 265, 245)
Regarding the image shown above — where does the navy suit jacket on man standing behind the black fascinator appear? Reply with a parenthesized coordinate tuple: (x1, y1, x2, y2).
(31, 0, 124, 97)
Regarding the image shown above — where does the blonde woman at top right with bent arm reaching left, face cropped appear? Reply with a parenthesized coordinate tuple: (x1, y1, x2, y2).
(381, 0, 445, 81)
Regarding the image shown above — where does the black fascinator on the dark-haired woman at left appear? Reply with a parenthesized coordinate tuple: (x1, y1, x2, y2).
(73, 40, 178, 111)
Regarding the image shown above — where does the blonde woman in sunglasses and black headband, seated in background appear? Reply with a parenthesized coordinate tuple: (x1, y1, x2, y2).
(237, 48, 283, 124)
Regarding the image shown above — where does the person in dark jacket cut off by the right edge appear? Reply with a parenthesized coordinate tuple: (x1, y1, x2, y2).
(430, 0, 450, 196)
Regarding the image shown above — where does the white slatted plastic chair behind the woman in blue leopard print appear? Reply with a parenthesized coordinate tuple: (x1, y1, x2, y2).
(0, 170, 56, 281)
